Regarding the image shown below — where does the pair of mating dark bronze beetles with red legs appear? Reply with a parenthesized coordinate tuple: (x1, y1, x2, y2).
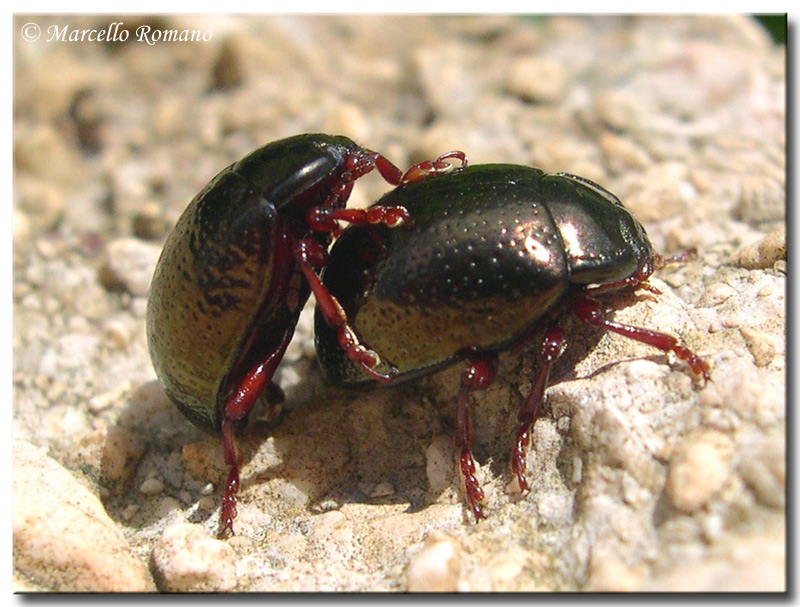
(147, 135, 708, 532)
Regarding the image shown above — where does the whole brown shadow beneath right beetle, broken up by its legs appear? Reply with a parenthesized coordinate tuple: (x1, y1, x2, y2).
(236, 302, 644, 516)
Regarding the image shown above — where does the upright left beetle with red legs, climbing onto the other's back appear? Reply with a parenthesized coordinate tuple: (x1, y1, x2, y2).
(147, 134, 467, 534)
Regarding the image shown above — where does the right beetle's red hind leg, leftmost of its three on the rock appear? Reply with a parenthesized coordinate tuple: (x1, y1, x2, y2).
(456, 356, 497, 522)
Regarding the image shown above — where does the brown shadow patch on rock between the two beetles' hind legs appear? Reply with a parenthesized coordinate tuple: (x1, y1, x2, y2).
(242, 383, 446, 513)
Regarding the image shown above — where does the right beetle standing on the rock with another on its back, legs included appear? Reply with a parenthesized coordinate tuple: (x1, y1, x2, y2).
(315, 164, 710, 521)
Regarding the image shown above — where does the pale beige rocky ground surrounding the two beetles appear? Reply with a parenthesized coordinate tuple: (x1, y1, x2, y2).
(13, 15, 786, 591)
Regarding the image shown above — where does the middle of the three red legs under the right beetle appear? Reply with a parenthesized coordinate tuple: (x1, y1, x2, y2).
(511, 327, 567, 493)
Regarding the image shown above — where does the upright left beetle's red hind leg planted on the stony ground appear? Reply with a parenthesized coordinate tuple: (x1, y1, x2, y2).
(220, 327, 294, 535)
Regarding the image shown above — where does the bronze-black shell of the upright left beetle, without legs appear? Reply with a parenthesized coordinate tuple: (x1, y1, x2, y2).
(147, 135, 376, 432)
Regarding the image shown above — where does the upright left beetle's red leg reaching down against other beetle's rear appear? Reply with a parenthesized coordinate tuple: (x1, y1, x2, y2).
(292, 238, 397, 383)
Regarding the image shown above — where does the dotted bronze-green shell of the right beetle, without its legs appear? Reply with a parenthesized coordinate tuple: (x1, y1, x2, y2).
(316, 164, 652, 385)
